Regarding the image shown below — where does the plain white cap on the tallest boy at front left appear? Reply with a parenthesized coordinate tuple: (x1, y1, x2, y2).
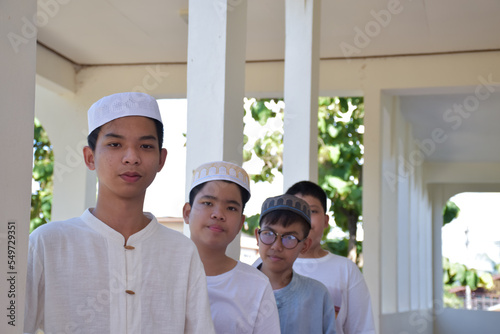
(88, 92, 162, 134)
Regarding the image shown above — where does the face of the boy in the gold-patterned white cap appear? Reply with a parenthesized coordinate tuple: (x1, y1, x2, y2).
(183, 181, 245, 251)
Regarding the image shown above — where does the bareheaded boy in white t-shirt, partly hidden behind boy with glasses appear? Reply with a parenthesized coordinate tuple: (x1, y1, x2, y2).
(286, 181, 375, 334)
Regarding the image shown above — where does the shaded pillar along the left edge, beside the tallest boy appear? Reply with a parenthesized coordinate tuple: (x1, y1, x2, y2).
(0, 0, 37, 334)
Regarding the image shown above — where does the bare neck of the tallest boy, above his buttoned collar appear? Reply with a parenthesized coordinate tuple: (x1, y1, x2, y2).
(92, 199, 150, 245)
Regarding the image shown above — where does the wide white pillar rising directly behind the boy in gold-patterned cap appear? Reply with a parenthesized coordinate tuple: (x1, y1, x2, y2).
(184, 0, 247, 259)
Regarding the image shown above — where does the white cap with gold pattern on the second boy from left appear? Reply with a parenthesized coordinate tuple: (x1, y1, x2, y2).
(189, 161, 250, 198)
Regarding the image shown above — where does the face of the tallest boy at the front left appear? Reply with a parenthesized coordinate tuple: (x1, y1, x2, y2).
(83, 116, 167, 198)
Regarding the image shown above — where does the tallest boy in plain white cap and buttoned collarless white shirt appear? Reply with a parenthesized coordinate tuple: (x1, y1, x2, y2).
(24, 93, 214, 334)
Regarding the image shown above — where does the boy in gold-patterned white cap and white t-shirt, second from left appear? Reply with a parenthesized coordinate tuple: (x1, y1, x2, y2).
(183, 161, 280, 334)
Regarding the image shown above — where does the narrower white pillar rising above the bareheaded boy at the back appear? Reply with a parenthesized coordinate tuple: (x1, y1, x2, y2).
(283, 0, 321, 190)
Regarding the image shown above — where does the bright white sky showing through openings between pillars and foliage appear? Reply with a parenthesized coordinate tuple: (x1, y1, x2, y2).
(144, 99, 500, 271)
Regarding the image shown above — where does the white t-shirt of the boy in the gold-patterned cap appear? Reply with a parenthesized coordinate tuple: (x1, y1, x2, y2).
(207, 262, 280, 334)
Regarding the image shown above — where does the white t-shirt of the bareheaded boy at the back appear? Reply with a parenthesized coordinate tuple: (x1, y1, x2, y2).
(293, 253, 375, 334)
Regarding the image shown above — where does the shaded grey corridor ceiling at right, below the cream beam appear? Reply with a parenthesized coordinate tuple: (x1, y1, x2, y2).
(400, 91, 500, 162)
